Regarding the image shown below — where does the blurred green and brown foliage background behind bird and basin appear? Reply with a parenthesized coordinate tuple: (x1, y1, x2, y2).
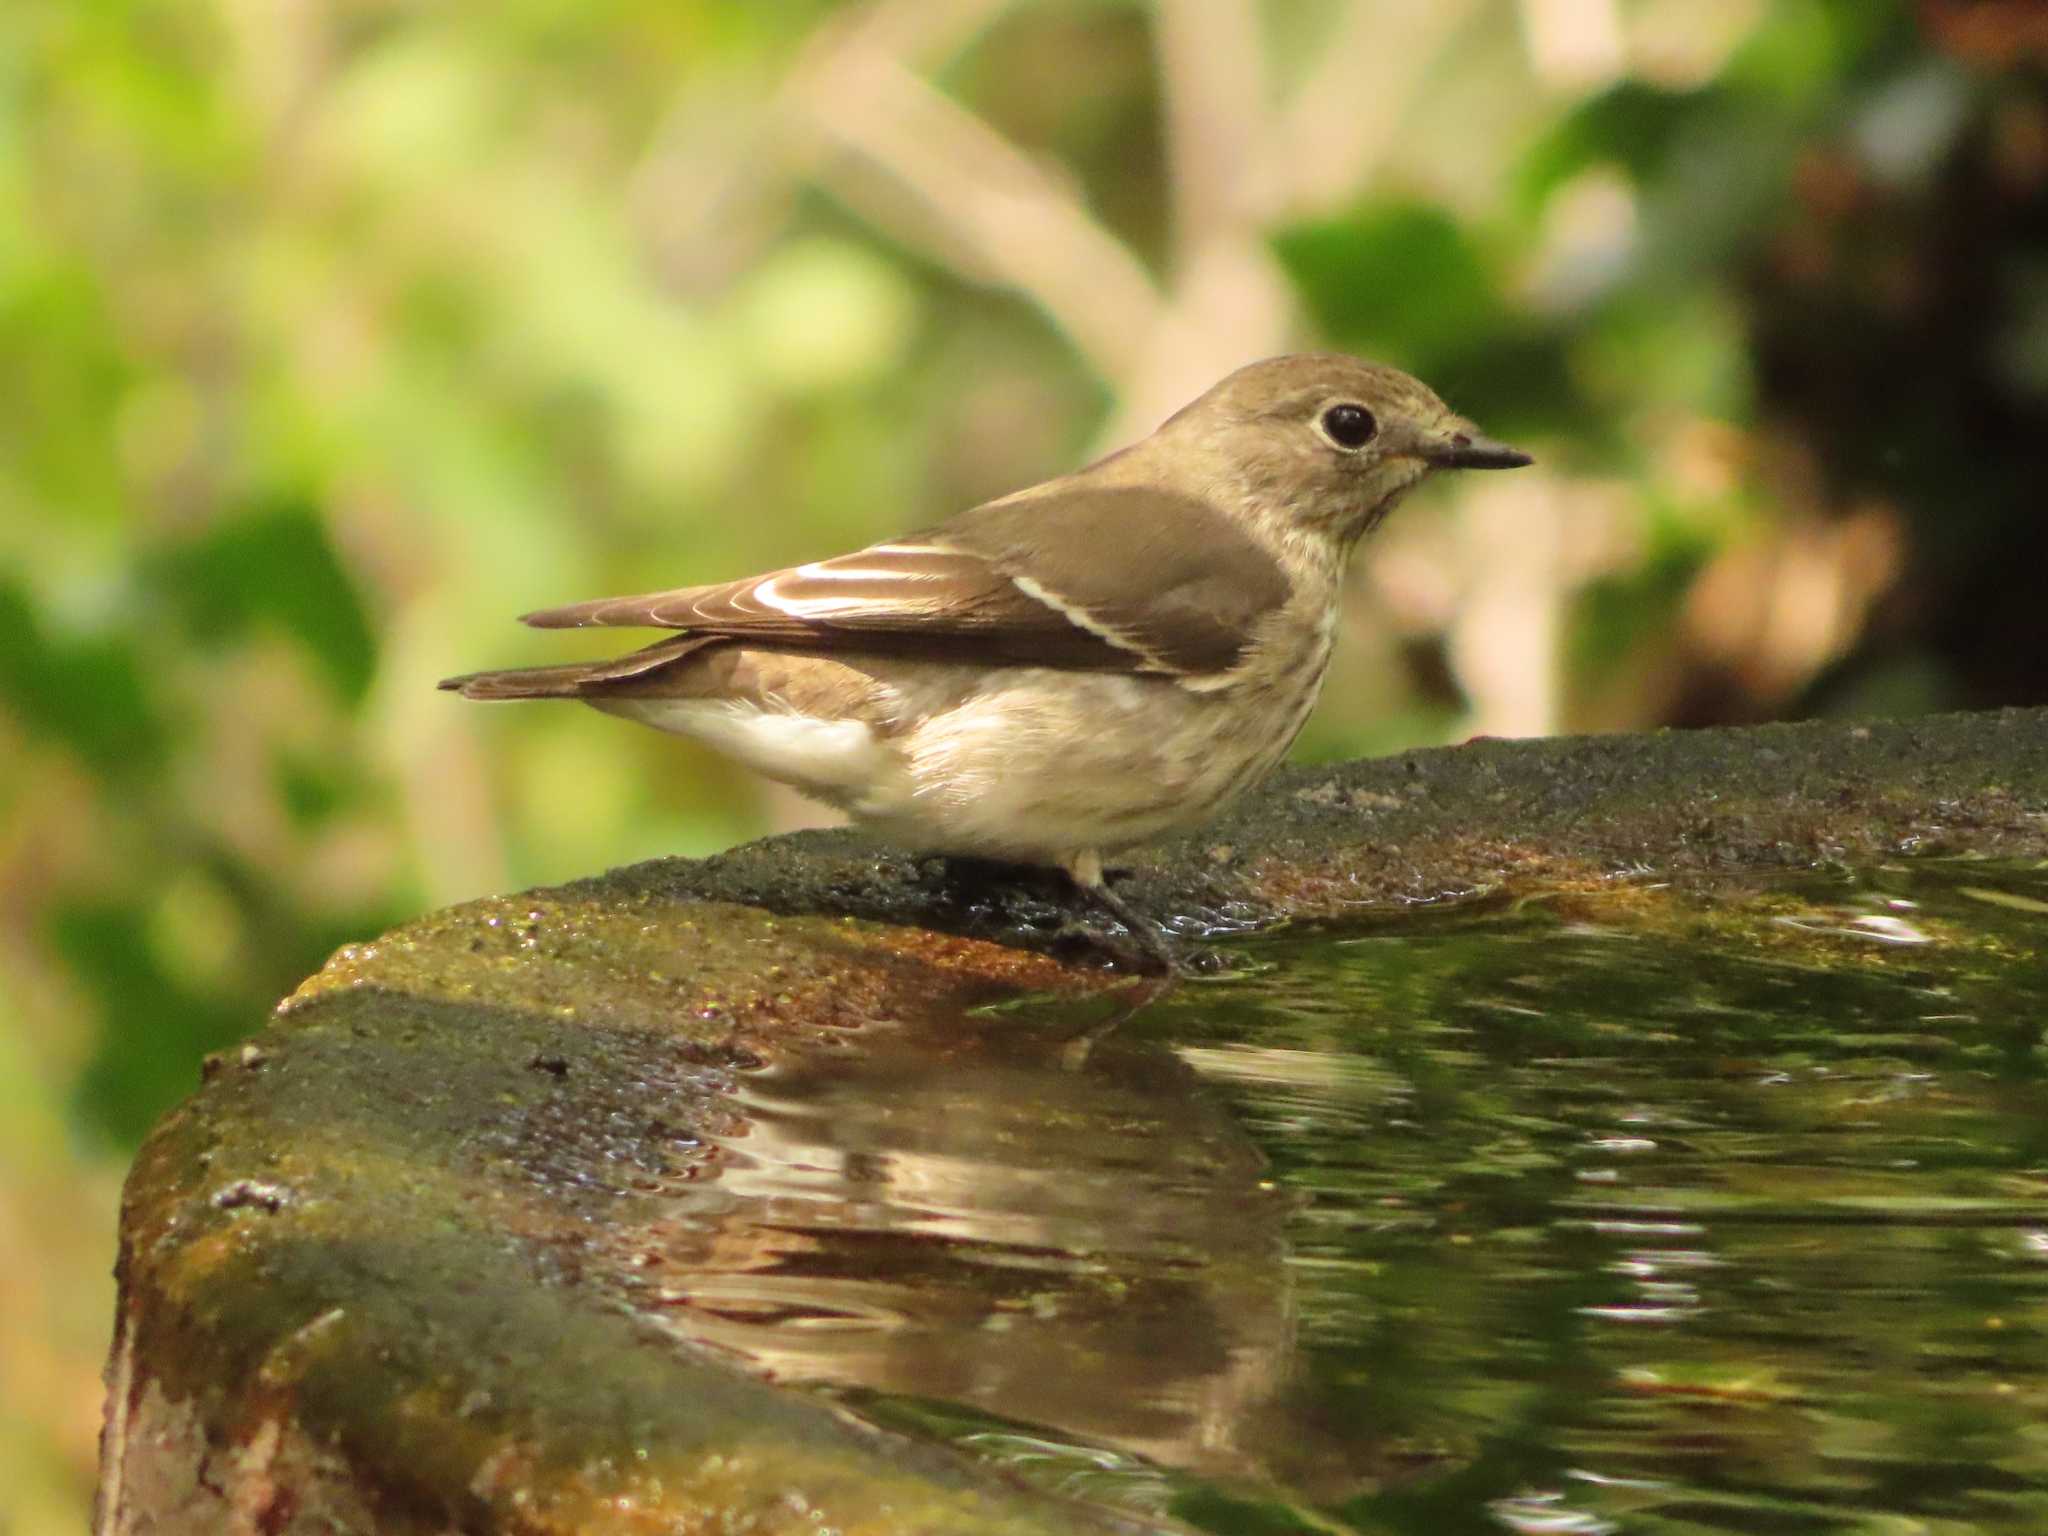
(0, 0, 2048, 1534)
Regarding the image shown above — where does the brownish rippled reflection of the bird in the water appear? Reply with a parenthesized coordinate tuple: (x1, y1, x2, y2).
(614, 999, 1294, 1477)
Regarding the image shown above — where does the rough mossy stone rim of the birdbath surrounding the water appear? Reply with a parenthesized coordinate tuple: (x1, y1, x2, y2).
(98, 711, 2048, 1536)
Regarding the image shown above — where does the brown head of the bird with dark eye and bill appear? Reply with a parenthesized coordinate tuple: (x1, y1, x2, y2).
(1159, 352, 1530, 543)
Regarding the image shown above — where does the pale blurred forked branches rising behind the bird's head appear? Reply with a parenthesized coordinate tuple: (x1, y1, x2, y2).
(643, 0, 1507, 436)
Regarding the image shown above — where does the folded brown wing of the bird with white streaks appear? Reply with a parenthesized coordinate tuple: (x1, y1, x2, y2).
(526, 485, 1288, 676)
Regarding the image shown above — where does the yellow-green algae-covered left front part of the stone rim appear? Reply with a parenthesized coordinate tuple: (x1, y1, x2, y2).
(100, 895, 1138, 1536)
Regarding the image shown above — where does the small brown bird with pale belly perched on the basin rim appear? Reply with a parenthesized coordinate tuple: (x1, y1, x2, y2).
(440, 354, 1530, 967)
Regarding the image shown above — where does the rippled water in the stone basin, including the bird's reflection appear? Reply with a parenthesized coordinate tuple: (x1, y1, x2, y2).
(618, 862, 2048, 1536)
